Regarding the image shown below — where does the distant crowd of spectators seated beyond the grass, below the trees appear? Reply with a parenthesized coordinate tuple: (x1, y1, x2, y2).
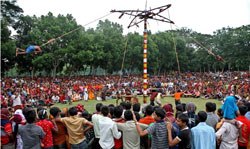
(1, 72, 250, 106)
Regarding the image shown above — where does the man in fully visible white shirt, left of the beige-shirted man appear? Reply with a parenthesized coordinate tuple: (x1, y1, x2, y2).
(99, 106, 121, 149)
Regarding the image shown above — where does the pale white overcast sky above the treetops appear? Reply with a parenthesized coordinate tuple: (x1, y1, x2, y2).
(17, 0, 250, 34)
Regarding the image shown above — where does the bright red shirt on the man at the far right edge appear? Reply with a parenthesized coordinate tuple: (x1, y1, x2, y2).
(236, 116, 250, 146)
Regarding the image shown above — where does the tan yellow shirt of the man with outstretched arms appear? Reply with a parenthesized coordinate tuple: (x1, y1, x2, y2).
(61, 115, 87, 144)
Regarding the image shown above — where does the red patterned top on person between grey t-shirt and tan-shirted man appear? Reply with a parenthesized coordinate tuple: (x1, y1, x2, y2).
(36, 120, 54, 147)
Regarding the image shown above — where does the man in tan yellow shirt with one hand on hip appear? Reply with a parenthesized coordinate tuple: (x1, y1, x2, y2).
(57, 107, 93, 149)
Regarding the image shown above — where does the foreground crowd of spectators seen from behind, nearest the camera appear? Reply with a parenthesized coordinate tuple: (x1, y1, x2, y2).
(1, 96, 250, 149)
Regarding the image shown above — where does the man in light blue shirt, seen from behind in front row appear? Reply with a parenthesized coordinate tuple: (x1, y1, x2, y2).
(191, 111, 216, 149)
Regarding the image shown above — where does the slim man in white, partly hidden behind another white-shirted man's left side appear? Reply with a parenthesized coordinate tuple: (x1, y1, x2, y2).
(92, 103, 103, 149)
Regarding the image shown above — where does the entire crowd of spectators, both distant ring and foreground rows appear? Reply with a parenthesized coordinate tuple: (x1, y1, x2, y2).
(1, 72, 250, 149)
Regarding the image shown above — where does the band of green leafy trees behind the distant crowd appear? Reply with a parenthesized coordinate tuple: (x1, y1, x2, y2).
(1, 1, 250, 76)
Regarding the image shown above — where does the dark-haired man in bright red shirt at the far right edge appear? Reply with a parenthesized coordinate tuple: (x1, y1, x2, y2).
(236, 105, 250, 149)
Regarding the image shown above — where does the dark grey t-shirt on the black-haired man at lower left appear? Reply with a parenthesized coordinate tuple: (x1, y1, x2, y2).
(18, 123, 45, 149)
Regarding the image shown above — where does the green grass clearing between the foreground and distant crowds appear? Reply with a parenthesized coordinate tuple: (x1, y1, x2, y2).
(50, 97, 222, 113)
